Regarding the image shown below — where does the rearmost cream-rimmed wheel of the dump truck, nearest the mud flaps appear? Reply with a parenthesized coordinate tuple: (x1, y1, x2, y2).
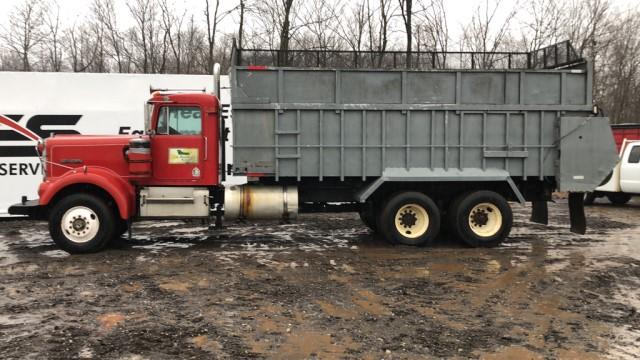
(449, 190, 513, 247)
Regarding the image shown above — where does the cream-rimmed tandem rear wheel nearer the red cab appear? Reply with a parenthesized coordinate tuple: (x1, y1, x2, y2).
(377, 191, 440, 246)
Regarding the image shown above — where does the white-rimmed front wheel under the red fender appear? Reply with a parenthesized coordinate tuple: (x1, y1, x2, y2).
(49, 194, 116, 254)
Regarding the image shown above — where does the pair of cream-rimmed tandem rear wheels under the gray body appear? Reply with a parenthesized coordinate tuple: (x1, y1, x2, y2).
(376, 191, 513, 247)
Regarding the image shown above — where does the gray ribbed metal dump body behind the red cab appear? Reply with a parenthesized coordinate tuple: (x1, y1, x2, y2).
(231, 46, 616, 197)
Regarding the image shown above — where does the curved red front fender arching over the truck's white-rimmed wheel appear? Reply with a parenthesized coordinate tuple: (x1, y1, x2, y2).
(38, 166, 135, 220)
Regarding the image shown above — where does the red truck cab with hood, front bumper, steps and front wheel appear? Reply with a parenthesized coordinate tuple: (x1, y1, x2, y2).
(9, 92, 220, 252)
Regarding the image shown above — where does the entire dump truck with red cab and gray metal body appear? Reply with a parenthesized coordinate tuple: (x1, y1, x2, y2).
(9, 43, 617, 253)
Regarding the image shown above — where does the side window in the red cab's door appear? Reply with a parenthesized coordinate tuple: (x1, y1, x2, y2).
(156, 106, 202, 135)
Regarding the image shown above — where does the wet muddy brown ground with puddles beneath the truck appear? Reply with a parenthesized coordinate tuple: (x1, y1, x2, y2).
(0, 202, 640, 359)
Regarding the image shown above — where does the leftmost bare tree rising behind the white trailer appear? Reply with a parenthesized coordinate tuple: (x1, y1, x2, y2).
(2, 0, 45, 71)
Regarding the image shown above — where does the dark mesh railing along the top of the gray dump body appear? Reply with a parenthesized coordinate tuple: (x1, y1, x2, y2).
(232, 41, 584, 70)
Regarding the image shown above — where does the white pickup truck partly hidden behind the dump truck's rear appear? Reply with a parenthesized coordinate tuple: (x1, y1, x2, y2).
(584, 139, 640, 205)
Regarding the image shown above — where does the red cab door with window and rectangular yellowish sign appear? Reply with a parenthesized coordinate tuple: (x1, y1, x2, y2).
(151, 105, 207, 185)
